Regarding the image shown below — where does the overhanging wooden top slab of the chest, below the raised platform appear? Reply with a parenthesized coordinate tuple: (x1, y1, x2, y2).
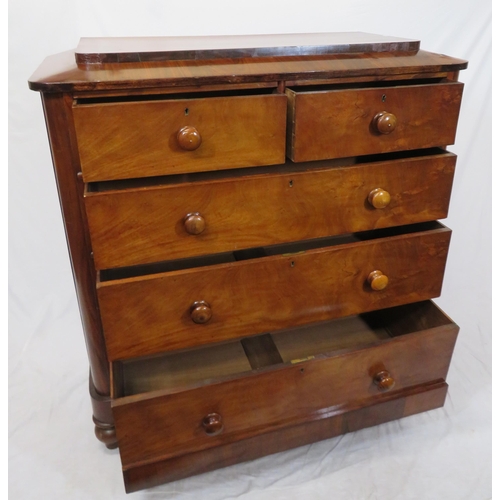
(29, 50, 467, 93)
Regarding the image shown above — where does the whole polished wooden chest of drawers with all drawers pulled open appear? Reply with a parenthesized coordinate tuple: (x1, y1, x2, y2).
(30, 33, 467, 491)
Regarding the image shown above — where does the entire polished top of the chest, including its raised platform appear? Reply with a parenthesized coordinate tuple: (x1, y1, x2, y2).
(29, 33, 467, 92)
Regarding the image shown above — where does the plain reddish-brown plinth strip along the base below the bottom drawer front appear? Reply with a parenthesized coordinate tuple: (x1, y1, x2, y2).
(123, 381, 448, 493)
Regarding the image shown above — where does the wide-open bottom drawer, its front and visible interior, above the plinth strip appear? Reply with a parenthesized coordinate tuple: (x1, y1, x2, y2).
(112, 301, 458, 471)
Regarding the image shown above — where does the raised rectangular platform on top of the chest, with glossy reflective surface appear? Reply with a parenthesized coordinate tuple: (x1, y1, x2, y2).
(75, 32, 420, 64)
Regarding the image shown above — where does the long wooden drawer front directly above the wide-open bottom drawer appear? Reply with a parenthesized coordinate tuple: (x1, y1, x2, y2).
(97, 228, 451, 360)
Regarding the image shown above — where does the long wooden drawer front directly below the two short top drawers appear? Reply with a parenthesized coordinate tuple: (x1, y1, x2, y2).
(85, 153, 456, 269)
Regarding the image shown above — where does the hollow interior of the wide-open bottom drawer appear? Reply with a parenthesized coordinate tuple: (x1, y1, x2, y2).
(112, 301, 453, 398)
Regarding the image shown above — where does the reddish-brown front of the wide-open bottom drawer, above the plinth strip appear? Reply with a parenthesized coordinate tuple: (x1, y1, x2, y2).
(113, 308, 458, 469)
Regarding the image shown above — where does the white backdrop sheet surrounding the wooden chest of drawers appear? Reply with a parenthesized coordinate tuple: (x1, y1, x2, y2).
(9, 0, 492, 500)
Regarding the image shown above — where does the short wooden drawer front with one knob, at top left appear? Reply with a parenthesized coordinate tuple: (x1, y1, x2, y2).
(73, 94, 286, 182)
